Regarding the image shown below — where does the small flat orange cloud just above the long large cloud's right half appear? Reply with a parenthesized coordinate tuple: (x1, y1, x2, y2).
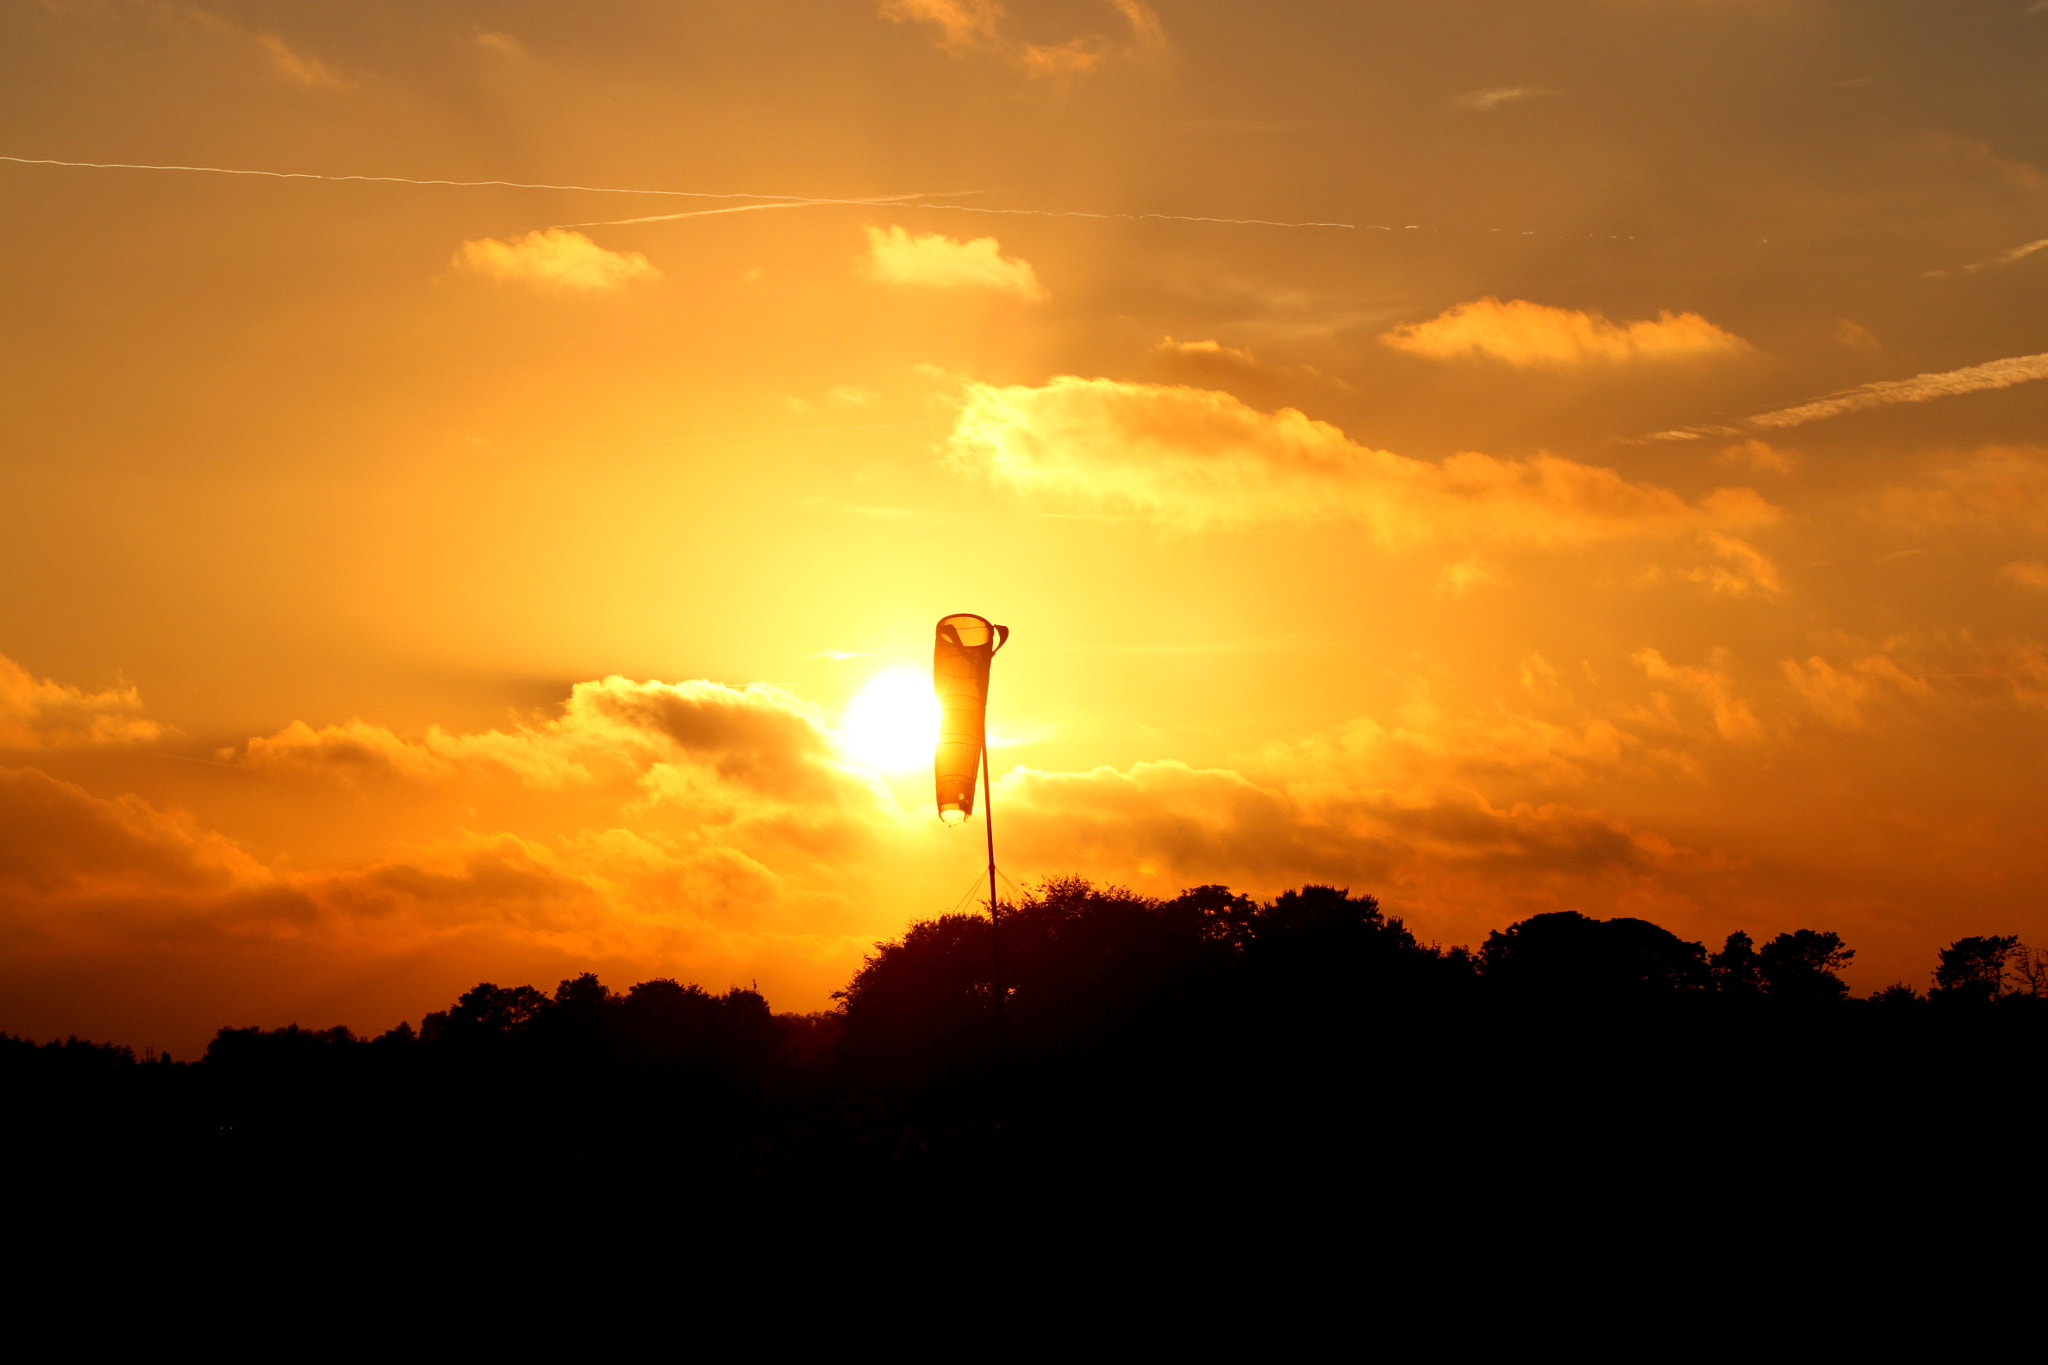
(1380, 297, 1749, 366)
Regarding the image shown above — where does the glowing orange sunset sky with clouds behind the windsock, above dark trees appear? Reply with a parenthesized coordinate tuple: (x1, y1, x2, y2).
(0, 0, 2048, 1056)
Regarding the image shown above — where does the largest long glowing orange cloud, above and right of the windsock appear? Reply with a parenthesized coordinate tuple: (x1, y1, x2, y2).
(946, 377, 1776, 546)
